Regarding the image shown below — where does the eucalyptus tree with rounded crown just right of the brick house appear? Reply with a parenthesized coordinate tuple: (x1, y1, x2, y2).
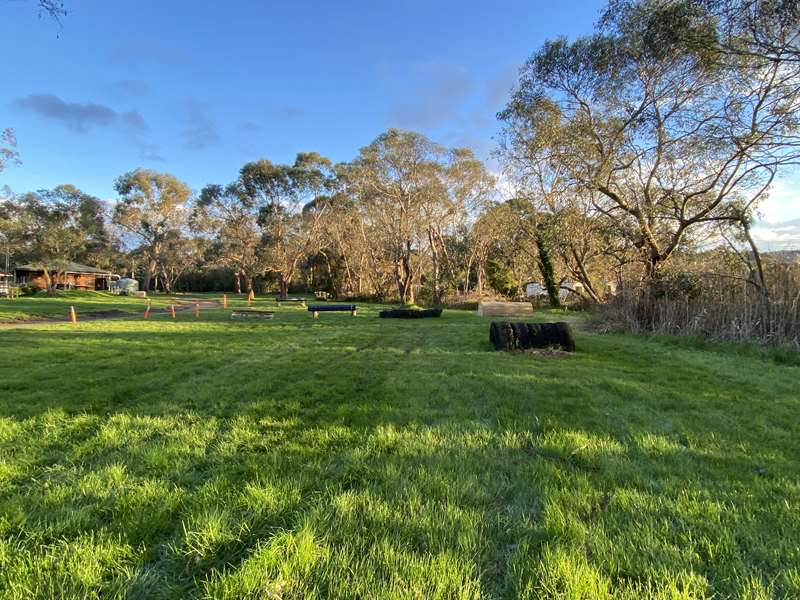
(112, 169, 192, 290)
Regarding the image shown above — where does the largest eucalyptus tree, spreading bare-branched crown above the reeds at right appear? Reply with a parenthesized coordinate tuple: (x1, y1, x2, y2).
(500, 0, 800, 279)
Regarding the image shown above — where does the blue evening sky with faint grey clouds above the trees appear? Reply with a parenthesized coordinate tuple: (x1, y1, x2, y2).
(0, 0, 800, 245)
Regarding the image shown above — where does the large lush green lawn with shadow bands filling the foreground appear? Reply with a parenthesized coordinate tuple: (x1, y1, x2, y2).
(0, 300, 800, 599)
